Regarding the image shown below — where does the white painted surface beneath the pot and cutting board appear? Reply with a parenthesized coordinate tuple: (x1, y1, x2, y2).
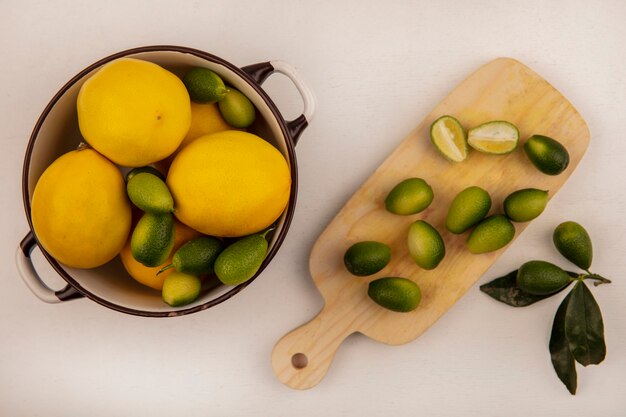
(0, 0, 626, 417)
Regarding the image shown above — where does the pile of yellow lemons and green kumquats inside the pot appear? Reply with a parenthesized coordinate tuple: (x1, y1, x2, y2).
(31, 58, 291, 305)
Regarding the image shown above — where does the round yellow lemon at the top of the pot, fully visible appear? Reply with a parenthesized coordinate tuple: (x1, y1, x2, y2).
(77, 58, 191, 167)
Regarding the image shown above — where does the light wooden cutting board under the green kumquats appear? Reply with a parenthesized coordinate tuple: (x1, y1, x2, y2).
(272, 58, 589, 389)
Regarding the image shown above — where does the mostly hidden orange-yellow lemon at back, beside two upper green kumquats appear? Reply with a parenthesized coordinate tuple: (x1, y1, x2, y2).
(155, 101, 232, 173)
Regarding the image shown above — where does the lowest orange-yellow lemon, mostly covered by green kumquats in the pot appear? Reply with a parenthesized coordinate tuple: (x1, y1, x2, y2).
(120, 221, 201, 290)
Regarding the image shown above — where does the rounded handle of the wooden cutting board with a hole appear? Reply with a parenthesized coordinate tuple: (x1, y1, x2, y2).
(272, 305, 355, 389)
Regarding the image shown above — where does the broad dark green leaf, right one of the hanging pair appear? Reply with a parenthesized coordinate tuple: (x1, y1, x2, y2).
(565, 281, 606, 366)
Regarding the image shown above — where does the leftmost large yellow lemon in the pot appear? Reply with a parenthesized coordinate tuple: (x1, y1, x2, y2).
(31, 149, 131, 268)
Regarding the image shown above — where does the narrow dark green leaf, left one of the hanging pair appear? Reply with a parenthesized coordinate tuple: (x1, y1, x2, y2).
(550, 291, 577, 395)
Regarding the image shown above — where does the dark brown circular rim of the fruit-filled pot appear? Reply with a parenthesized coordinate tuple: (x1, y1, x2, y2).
(22, 45, 298, 317)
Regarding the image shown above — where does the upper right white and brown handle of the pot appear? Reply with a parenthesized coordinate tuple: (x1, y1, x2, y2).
(241, 60, 316, 145)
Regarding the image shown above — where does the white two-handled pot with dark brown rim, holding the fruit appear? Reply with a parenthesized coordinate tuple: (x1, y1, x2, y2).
(16, 46, 315, 317)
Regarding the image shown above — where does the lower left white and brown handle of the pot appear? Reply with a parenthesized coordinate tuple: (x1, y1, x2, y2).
(15, 231, 83, 303)
